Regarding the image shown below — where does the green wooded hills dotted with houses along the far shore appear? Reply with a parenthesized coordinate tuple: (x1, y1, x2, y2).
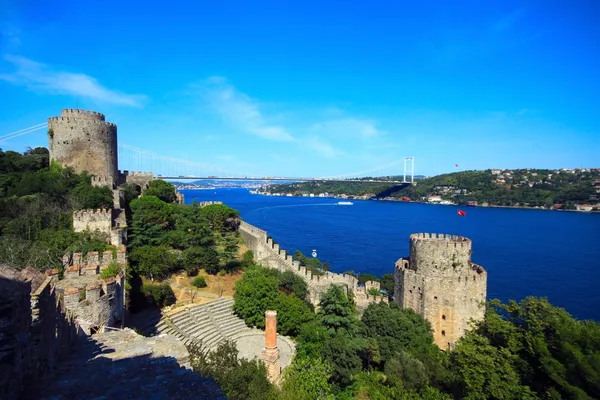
(267, 169, 600, 209)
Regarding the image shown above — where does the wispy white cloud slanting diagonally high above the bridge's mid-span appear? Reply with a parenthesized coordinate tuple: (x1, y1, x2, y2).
(203, 77, 295, 142)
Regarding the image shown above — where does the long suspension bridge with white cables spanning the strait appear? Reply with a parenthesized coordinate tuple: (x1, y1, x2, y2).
(0, 122, 415, 184)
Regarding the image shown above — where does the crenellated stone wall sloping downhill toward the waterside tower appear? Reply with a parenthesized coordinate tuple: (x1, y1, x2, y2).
(239, 221, 387, 308)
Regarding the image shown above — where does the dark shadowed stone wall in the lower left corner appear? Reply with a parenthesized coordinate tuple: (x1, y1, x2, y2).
(0, 267, 80, 400)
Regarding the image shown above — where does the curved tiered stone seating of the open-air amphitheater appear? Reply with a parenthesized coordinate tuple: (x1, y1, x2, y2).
(156, 298, 251, 349)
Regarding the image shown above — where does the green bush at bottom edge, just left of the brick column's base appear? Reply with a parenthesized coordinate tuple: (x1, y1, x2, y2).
(188, 341, 276, 400)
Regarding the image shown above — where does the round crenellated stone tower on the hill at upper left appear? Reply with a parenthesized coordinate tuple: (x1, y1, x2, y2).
(48, 108, 118, 186)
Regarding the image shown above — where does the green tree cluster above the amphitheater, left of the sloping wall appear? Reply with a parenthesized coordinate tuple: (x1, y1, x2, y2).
(129, 191, 239, 279)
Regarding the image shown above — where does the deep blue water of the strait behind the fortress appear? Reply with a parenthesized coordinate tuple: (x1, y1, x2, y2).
(183, 189, 600, 321)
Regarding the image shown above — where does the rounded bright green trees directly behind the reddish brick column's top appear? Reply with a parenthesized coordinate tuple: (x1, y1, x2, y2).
(233, 265, 314, 336)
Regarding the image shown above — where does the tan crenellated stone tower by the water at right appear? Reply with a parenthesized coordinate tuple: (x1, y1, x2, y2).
(394, 233, 487, 350)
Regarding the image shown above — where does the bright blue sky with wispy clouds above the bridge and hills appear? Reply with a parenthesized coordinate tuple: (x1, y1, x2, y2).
(0, 0, 600, 176)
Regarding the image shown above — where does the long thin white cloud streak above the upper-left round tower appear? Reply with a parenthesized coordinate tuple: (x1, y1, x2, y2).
(0, 55, 147, 107)
